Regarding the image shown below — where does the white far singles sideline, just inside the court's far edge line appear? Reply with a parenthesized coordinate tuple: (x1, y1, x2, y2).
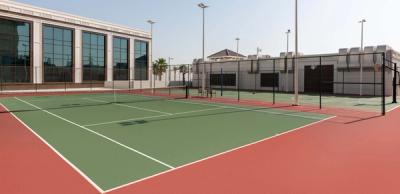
(170, 100, 324, 120)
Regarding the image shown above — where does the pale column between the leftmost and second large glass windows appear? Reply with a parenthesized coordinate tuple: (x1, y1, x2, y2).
(32, 20, 43, 84)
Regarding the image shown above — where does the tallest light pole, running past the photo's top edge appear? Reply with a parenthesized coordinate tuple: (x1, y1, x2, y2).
(294, 0, 299, 106)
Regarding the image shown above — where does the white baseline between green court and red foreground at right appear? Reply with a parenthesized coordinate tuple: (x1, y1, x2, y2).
(105, 116, 336, 193)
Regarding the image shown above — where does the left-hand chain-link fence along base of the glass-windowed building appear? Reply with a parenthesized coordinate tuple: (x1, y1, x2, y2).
(0, 65, 192, 93)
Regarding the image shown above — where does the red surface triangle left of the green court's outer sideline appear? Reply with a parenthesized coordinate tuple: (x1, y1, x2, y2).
(0, 106, 98, 194)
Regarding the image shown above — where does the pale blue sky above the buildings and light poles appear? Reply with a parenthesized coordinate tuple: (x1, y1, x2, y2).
(14, 0, 400, 63)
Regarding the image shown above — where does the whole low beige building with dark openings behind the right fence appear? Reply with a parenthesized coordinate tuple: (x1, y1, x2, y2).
(193, 45, 400, 96)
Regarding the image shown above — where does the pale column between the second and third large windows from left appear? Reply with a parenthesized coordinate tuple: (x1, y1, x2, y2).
(74, 29, 83, 83)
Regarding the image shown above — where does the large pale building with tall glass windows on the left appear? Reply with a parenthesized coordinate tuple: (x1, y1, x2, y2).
(0, 0, 151, 87)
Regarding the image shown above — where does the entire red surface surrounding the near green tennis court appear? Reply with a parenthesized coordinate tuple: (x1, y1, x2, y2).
(0, 98, 400, 194)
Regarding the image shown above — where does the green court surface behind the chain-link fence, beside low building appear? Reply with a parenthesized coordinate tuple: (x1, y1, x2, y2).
(198, 89, 398, 112)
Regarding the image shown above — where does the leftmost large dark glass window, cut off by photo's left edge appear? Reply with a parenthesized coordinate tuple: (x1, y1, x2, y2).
(0, 18, 31, 83)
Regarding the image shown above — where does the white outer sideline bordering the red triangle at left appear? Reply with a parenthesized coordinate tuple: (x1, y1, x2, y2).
(0, 103, 104, 193)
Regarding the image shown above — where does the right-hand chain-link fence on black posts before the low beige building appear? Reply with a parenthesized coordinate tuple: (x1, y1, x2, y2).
(191, 51, 399, 114)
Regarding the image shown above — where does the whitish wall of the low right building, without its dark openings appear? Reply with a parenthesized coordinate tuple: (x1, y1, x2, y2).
(193, 46, 393, 96)
